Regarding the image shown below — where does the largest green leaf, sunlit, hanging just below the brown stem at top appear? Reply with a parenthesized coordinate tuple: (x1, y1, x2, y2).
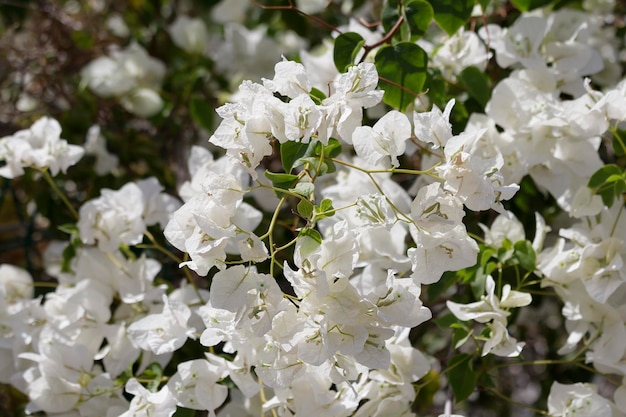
(375, 42, 428, 111)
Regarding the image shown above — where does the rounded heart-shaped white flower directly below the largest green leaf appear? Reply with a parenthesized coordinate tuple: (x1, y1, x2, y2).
(352, 110, 411, 167)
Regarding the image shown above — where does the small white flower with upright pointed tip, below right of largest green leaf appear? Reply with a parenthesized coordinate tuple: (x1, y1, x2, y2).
(413, 99, 455, 149)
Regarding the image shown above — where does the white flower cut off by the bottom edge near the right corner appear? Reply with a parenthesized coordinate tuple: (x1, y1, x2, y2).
(548, 381, 613, 417)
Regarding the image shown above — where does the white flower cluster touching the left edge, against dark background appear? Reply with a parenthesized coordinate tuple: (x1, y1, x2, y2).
(0, 117, 84, 178)
